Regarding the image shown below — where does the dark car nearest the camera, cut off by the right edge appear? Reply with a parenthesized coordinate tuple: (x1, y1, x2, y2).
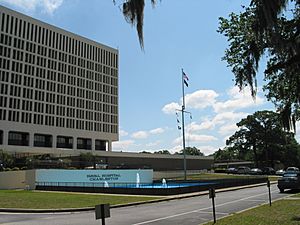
(277, 171, 300, 193)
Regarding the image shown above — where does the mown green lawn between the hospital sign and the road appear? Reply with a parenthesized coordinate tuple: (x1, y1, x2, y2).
(0, 190, 162, 209)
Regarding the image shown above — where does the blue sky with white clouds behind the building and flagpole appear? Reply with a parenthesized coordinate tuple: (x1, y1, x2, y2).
(0, 0, 284, 155)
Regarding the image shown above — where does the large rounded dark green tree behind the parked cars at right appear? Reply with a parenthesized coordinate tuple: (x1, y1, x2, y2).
(226, 110, 296, 167)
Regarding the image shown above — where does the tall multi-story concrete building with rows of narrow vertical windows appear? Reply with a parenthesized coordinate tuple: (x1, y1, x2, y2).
(0, 6, 118, 154)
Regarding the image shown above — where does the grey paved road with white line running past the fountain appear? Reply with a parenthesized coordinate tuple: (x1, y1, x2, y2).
(0, 185, 289, 225)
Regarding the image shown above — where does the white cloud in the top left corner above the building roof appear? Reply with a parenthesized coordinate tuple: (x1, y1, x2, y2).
(0, 0, 63, 14)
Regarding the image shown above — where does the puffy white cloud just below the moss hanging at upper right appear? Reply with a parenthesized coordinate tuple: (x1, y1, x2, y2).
(213, 87, 264, 113)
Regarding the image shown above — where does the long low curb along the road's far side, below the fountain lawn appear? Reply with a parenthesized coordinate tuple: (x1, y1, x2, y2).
(0, 181, 277, 213)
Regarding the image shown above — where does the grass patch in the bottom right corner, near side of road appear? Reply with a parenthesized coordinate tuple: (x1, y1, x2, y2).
(206, 200, 300, 225)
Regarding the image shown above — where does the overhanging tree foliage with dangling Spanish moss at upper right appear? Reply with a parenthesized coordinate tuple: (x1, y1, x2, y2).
(218, 0, 300, 130)
